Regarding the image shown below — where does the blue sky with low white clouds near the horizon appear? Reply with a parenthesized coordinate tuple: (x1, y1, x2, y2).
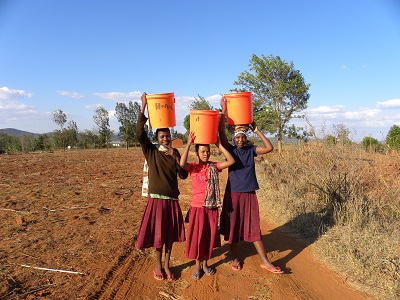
(0, 0, 400, 141)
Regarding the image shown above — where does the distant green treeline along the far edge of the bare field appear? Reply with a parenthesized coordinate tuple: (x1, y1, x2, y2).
(0, 101, 187, 154)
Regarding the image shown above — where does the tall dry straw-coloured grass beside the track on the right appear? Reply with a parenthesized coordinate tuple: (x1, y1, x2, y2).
(257, 143, 400, 299)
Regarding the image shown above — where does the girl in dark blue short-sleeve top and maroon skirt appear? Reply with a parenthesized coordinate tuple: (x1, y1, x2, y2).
(219, 97, 283, 274)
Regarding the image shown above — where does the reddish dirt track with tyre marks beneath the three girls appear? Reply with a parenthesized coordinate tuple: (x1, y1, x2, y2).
(91, 172, 371, 300)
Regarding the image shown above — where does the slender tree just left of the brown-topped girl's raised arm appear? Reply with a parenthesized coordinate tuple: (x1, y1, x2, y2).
(115, 101, 140, 149)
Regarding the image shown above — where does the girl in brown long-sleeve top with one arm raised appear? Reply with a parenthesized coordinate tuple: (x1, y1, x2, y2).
(136, 93, 188, 281)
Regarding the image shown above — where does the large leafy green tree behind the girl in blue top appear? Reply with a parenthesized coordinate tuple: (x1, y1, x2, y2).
(234, 54, 310, 153)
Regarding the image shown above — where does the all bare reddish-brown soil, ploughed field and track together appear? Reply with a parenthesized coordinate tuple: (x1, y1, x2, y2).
(0, 149, 371, 299)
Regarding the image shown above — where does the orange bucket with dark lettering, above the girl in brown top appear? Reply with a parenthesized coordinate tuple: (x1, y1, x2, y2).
(146, 93, 176, 128)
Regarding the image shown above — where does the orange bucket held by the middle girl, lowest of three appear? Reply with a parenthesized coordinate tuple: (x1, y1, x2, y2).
(190, 110, 219, 144)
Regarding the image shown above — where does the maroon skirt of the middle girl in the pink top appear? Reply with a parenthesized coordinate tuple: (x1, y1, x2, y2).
(185, 207, 221, 260)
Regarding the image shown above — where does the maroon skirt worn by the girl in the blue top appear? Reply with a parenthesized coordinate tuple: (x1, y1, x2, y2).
(220, 191, 262, 244)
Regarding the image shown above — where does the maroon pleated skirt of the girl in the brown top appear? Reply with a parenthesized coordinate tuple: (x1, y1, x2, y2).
(136, 195, 185, 249)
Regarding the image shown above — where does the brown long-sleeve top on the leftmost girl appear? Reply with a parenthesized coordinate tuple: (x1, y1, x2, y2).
(136, 113, 188, 199)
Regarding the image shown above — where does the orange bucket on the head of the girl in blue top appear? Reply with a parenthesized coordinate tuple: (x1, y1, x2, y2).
(224, 92, 253, 125)
